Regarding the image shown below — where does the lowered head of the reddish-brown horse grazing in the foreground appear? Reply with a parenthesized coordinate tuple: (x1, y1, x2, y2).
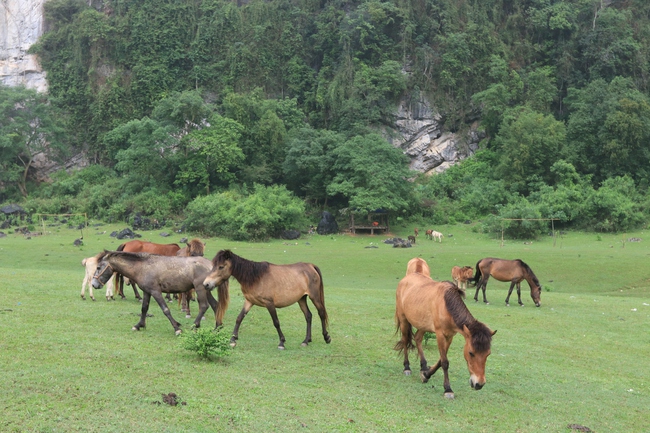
(462, 321, 497, 390)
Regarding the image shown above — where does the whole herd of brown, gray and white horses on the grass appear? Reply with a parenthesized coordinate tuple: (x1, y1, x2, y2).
(81, 236, 541, 398)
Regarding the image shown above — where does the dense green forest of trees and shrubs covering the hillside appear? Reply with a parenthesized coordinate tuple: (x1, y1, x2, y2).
(0, 0, 650, 239)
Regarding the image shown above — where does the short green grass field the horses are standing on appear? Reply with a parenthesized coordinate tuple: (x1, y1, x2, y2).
(0, 221, 650, 432)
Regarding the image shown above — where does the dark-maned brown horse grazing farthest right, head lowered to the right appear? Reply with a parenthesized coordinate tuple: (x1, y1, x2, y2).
(473, 257, 542, 307)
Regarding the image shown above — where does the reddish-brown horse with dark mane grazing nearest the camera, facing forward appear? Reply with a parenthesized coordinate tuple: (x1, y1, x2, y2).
(395, 273, 496, 398)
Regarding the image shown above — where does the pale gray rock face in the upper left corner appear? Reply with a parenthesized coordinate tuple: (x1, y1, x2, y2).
(0, 0, 47, 92)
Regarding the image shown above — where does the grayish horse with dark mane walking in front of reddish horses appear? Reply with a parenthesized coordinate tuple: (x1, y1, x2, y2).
(92, 251, 229, 335)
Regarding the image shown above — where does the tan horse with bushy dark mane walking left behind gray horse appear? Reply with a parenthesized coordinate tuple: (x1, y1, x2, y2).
(203, 250, 332, 349)
